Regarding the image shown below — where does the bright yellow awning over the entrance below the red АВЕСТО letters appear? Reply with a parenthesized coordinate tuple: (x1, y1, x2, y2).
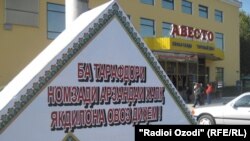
(144, 37, 224, 60)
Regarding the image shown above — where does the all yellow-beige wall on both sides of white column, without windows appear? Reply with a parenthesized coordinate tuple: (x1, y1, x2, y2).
(0, 0, 240, 87)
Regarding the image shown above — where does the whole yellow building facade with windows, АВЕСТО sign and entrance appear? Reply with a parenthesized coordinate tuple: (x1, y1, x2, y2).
(0, 0, 241, 89)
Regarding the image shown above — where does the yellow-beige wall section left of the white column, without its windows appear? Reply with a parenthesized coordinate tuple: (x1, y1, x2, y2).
(0, 0, 64, 87)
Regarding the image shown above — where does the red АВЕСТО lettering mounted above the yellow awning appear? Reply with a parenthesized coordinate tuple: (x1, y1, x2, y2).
(170, 24, 214, 42)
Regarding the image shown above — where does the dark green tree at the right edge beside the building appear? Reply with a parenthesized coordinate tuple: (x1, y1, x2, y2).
(240, 11, 250, 76)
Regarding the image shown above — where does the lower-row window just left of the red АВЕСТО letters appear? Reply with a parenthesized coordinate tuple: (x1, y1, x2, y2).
(141, 18, 155, 37)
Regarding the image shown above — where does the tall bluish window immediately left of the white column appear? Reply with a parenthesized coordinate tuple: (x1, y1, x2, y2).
(47, 3, 65, 39)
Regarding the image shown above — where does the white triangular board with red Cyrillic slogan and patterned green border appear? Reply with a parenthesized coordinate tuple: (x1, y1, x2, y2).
(0, 1, 195, 141)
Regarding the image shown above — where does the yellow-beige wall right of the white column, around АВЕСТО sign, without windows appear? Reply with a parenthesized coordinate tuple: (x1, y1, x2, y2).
(90, 0, 240, 86)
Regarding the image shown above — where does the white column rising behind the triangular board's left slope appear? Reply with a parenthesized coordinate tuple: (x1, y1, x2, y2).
(65, 0, 88, 28)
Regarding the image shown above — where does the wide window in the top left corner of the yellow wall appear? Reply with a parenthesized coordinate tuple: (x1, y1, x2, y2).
(5, 0, 39, 26)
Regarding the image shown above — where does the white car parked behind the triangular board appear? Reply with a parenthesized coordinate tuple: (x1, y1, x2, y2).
(192, 92, 250, 125)
